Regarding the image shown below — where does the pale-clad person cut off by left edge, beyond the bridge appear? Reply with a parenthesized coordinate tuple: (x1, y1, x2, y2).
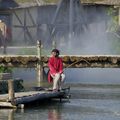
(0, 20, 7, 54)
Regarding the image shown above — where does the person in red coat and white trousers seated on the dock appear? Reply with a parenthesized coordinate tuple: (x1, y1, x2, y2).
(48, 49, 65, 91)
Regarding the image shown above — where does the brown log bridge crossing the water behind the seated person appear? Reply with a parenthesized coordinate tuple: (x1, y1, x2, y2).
(0, 55, 120, 68)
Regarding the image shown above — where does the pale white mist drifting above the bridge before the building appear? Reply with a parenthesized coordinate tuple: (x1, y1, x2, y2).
(50, 0, 112, 55)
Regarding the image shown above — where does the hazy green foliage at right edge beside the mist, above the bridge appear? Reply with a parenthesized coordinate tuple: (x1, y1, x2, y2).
(107, 8, 120, 54)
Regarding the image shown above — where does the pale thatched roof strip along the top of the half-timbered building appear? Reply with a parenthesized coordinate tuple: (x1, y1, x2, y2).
(0, 0, 120, 9)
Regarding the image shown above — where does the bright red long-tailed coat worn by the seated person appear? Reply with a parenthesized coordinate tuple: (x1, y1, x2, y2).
(48, 57, 63, 82)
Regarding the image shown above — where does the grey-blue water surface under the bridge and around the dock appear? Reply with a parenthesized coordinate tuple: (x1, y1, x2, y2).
(0, 69, 120, 120)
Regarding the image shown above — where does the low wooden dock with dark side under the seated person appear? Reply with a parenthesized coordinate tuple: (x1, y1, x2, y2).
(0, 88, 69, 108)
